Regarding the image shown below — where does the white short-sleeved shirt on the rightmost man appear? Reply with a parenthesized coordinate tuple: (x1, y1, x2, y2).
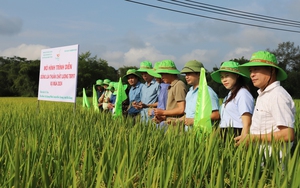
(250, 81, 296, 134)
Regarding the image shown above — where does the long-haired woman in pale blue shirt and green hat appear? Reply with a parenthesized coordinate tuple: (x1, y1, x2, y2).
(211, 61, 254, 140)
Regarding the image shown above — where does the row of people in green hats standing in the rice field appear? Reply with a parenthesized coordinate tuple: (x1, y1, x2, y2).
(96, 51, 295, 155)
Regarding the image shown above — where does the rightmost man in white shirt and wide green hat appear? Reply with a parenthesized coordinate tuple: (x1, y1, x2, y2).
(235, 51, 295, 153)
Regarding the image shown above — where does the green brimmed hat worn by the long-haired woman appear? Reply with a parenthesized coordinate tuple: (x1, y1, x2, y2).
(211, 61, 250, 83)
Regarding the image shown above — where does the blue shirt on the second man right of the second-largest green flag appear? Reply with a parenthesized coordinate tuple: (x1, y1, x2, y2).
(141, 79, 159, 122)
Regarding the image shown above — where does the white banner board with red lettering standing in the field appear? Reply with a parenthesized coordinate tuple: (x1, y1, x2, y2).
(38, 44, 79, 103)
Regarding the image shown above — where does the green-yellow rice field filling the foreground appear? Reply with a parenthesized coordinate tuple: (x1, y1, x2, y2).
(0, 98, 300, 187)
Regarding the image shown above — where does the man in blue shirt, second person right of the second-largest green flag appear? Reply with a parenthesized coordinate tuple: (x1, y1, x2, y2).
(135, 61, 159, 123)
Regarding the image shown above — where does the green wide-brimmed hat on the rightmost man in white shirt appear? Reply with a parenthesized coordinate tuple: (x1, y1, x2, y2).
(239, 51, 287, 81)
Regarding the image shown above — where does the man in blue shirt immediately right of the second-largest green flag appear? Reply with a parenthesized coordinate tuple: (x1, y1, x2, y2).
(123, 69, 143, 119)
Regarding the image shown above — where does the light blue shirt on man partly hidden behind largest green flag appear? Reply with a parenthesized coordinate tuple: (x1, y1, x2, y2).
(185, 86, 219, 118)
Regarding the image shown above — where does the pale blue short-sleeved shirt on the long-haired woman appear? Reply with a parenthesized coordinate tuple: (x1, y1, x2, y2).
(220, 88, 254, 128)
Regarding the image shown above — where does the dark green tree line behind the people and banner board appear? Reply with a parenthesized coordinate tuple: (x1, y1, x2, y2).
(0, 42, 300, 99)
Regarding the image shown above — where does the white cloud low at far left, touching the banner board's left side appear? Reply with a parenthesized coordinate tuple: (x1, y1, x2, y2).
(0, 44, 49, 60)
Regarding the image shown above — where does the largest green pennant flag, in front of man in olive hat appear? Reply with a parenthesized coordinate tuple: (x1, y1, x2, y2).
(194, 68, 212, 133)
